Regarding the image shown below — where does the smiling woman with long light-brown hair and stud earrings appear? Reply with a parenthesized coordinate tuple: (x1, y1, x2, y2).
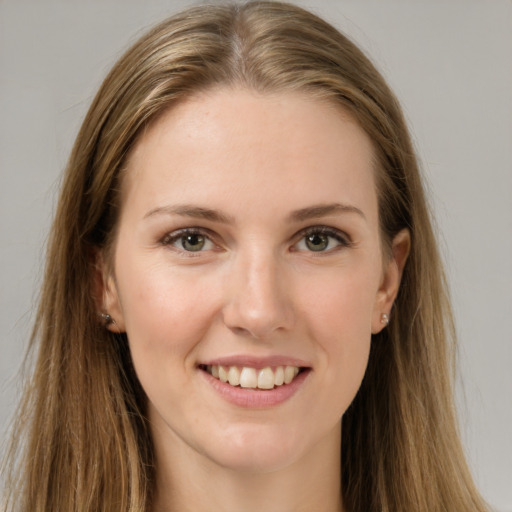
(4, 2, 486, 512)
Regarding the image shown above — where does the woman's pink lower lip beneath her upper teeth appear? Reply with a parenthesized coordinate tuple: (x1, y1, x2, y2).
(199, 369, 311, 409)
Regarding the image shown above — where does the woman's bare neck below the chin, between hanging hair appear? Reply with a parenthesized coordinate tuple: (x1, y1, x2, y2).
(152, 422, 343, 512)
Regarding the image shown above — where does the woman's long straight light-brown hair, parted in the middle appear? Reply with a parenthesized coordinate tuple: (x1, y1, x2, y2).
(6, 2, 487, 512)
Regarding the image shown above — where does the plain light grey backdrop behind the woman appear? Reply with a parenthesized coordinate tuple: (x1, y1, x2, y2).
(0, 0, 512, 512)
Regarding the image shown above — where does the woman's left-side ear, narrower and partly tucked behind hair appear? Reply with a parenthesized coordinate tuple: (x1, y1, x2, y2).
(92, 250, 125, 333)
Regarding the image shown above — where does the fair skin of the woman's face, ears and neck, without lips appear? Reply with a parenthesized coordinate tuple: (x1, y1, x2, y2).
(102, 88, 409, 512)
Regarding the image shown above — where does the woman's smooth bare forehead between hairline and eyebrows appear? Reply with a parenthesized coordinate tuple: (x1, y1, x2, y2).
(123, 88, 376, 222)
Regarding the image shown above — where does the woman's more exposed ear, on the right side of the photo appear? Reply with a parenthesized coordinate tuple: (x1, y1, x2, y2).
(372, 229, 411, 334)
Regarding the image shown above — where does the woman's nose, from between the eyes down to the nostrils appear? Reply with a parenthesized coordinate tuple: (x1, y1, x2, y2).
(223, 251, 295, 339)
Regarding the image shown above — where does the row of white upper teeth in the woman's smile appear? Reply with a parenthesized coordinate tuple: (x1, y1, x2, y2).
(206, 365, 299, 389)
